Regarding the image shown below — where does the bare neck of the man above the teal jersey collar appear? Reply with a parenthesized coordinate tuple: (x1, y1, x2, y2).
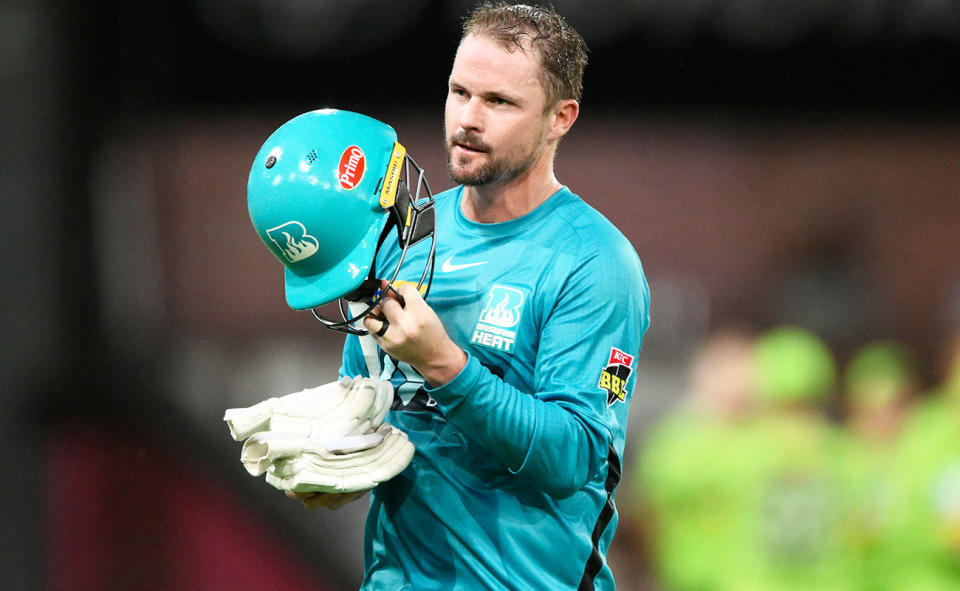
(460, 160, 562, 224)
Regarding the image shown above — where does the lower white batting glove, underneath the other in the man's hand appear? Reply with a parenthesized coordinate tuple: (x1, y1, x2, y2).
(266, 423, 414, 493)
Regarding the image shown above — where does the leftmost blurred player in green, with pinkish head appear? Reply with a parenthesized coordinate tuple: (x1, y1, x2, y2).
(621, 329, 756, 591)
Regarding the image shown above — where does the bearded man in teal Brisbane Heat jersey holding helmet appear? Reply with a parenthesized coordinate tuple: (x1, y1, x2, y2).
(291, 4, 649, 591)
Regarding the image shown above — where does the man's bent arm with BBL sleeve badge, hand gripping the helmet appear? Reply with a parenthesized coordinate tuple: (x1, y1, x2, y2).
(367, 250, 649, 497)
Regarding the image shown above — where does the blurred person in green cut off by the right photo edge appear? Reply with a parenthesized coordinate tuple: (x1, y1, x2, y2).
(888, 339, 960, 591)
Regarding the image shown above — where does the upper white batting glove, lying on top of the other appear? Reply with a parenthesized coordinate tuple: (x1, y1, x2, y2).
(223, 377, 393, 441)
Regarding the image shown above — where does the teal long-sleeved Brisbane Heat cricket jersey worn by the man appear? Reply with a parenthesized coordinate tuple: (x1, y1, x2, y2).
(341, 187, 650, 591)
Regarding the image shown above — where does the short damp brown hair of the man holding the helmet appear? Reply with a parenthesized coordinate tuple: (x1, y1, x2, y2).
(463, 2, 588, 109)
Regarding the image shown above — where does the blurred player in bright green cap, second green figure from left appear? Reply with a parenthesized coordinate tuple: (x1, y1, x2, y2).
(721, 326, 855, 591)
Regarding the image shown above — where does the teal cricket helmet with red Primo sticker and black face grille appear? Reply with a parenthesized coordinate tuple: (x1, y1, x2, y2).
(247, 109, 435, 333)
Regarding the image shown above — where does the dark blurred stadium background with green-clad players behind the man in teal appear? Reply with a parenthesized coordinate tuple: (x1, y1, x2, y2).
(0, 0, 960, 591)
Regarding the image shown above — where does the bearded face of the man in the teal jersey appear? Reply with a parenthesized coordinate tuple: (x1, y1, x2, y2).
(445, 35, 548, 186)
